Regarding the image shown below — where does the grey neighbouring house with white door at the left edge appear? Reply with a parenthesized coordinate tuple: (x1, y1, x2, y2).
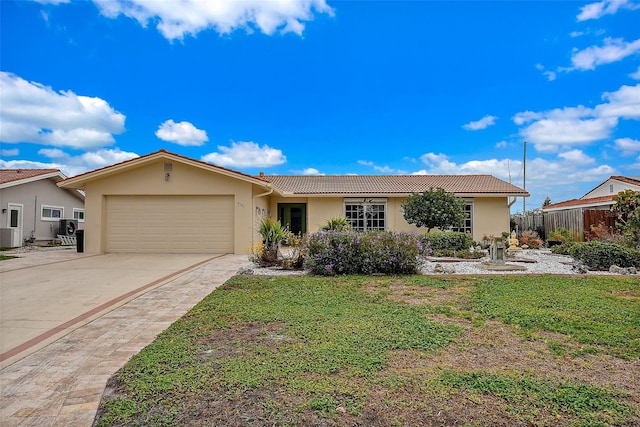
(0, 169, 84, 247)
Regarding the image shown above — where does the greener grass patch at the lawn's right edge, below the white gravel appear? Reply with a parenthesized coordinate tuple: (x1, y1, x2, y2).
(471, 276, 640, 359)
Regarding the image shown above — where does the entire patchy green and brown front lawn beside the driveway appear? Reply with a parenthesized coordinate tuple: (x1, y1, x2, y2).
(97, 276, 640, 426)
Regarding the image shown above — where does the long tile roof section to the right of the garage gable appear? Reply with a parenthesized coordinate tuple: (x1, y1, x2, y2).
(261, 175, 529, 196)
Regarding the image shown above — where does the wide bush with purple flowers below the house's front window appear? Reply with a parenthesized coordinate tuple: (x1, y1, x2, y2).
(305, 231, 422, 276)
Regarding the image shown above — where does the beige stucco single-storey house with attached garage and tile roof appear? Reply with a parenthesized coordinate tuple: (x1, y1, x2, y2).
(58, 150, 529, 254)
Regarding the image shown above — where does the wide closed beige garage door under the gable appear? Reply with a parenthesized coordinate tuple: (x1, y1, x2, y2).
(105, 196, 233, 253)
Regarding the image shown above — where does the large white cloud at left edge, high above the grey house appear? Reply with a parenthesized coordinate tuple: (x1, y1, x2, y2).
(0, 71, 125, 149)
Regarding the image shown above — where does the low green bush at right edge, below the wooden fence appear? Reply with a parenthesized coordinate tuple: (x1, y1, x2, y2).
(567, 240, 640, 270)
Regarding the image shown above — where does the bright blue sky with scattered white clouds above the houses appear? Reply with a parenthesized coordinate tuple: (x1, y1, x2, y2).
(0, 0, 640, 209)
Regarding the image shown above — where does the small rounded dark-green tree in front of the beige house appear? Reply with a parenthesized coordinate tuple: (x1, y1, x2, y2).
(402, 188, 465, 232)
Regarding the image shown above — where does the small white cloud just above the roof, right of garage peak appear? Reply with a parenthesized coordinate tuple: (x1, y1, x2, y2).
(201, 141, 287, 168)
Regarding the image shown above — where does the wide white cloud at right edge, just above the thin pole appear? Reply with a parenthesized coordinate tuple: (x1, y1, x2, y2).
(513, 84, 640, 152)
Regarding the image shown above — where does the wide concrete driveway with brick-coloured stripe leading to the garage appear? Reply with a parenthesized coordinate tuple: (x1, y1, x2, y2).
(0, 251, 249, 426)
